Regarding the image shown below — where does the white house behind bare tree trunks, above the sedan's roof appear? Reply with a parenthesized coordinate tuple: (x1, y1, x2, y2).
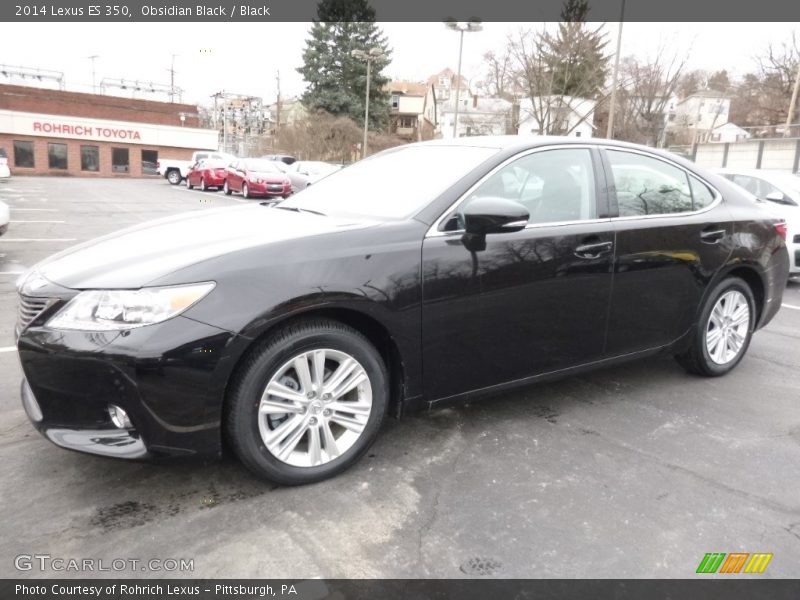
(517, 96, 597, 137)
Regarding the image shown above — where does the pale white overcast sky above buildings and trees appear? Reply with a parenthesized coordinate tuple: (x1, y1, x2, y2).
(0, 23, 800, 104)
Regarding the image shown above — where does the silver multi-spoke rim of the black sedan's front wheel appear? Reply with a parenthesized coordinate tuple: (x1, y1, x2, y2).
(258, 349, 372, 467)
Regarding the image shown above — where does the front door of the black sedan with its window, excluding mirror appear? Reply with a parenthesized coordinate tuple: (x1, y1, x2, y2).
(422, 146, 614, 399)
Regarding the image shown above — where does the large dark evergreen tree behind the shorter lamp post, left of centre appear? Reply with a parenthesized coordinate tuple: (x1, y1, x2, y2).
(297, 0, 390, 130)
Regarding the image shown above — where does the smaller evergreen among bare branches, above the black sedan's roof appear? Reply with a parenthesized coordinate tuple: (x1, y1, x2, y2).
(542, 0, 608, 98)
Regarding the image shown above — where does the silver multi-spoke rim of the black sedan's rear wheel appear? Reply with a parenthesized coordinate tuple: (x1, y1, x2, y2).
(706, 290, 750, 365)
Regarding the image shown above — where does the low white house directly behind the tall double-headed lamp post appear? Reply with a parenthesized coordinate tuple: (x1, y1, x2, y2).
(439, 94, 513, 138)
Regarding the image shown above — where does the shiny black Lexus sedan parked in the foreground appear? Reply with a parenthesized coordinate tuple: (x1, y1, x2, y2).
(17, 137, 788, 484)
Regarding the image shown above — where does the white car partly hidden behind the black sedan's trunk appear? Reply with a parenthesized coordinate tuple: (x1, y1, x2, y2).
(714, 168, 800, 277)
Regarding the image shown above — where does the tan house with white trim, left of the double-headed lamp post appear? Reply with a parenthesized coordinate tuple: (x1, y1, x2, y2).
(386, 81, 437, 141)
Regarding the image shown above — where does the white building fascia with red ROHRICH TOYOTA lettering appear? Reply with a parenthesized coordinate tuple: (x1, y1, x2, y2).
(0, 110, 218, 148)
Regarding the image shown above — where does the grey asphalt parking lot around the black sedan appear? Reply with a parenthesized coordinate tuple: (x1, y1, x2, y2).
(0, 177, 800, 578)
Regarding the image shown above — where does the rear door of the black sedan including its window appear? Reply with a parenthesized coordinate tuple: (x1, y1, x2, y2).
(603, 148, 733, 356)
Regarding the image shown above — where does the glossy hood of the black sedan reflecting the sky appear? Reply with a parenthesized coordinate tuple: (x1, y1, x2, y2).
(34, 204, 375, 289)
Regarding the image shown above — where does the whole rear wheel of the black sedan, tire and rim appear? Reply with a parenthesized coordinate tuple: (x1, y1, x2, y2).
(675, 277, 756, 377)
